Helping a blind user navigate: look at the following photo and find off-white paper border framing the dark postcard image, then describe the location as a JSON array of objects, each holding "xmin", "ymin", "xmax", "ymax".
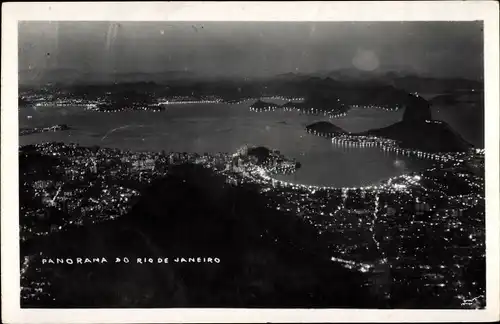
[{"xmin": 1, "ymin": 1, "xmax": 500, "ymax": 323}]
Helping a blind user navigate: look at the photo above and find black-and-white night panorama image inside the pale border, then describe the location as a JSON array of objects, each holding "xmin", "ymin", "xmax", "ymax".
[{"xmin": 2, "ymin": 4, "xmax": 498, "ymax": 322}]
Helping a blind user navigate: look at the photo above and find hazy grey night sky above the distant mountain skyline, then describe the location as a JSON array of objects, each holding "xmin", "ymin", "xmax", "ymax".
[{"xmin": 19, "ymin": 21, "xmax": 483, "ymax": 79}]
